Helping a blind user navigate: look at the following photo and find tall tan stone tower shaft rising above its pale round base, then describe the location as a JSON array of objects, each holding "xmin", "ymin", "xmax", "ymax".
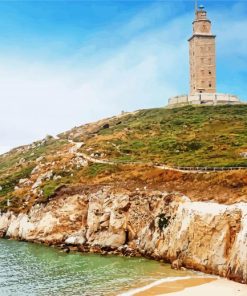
[{"xmin": 189, "ymin": 6, "xmax": 216, "ymax": 95}]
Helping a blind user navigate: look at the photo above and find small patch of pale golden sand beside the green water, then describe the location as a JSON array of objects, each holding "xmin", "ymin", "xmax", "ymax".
[{"xmin": 123, "ymin": 277, "xmax": 247, "ymax": 296}]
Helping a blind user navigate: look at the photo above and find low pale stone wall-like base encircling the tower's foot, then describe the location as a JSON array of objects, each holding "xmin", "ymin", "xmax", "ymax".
[{"xmin": 167, "ymin": 93, "xmax": 242, "ymax": 108}]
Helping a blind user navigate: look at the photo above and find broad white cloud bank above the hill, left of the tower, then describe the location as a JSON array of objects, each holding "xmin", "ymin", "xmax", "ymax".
[{"xmin": 0, "ymin": 8, "xmax": 187, "ymax": 151}]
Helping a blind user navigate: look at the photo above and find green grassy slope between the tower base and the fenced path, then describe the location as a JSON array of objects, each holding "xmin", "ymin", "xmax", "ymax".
[{"xmin": 85, "ymin": 105, "xmax": 247, "ymax": 167}]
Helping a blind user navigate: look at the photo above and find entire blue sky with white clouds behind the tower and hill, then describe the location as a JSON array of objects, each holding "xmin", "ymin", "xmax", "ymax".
[{"xmin": 0, "ymin": 0, "xmax": 247, "ymax": 152}]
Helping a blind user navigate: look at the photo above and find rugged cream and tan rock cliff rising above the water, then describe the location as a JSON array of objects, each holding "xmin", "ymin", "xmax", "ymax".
[{"xmin": 0, "ymin": 187, "xmax": 247, "ymax": 283}]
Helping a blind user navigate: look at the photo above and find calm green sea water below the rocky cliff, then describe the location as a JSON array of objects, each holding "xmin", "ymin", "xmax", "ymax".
[{"xmin": 0, "ymin": 239, "xmax": 191, "ymax": 296}]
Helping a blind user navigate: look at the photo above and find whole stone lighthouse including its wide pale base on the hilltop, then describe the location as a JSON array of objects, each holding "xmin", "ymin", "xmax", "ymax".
[{"xmin": 168, "ymin": 5, "xmax": 241, "ymax": 108}]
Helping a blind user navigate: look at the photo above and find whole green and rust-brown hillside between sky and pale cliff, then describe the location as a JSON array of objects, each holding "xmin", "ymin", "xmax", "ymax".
[{"xmin": 0, "ymin": 105, "xmax": 247, "ymax": 212}]
